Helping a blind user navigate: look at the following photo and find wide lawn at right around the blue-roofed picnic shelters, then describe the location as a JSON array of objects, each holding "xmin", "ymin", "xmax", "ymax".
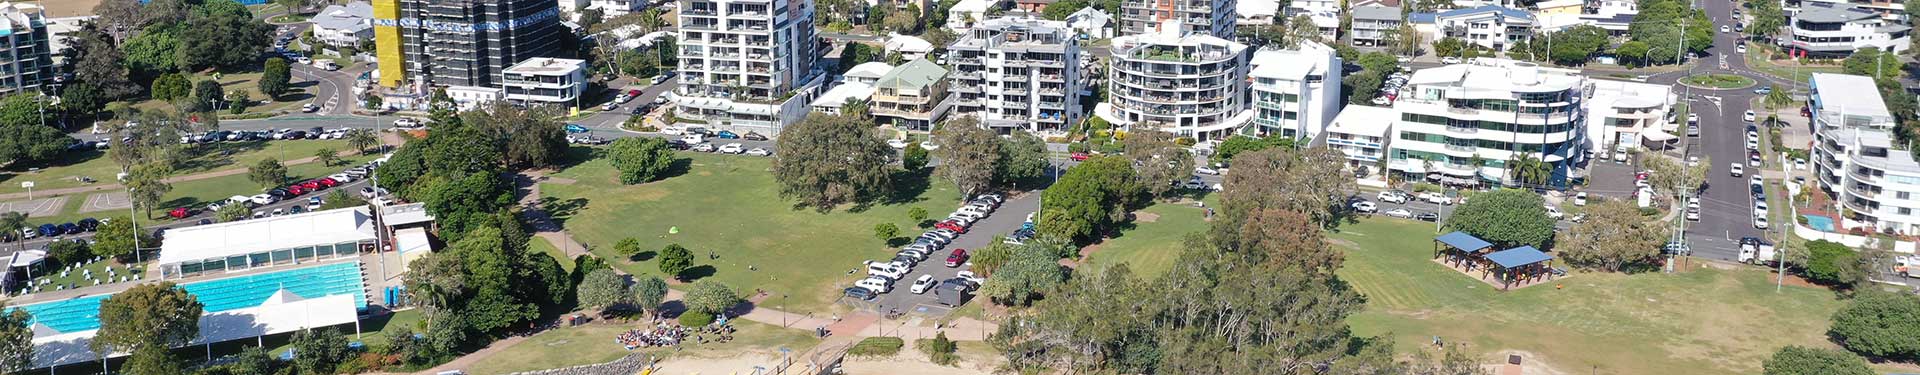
[{"xmin": 1332, "ymin": 219, "xmax": 1841, "ymax": 373}]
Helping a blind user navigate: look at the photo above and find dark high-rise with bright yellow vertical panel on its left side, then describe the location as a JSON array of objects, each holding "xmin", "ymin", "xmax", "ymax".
[{"xmin": 372, "ymin": 0, "xmax": 574, "ymax": 88}]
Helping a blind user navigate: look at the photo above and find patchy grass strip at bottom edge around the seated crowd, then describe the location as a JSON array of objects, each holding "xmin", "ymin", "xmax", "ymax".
[{"xmin": 467, "ymin": 319, "xmax": 820, "ymax": 375}]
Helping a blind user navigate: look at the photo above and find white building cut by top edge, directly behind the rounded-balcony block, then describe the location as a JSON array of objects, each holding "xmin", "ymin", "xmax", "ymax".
[{"xmin": 1119, "ymin": 0, "xmax": 1236, "ymax": 38}]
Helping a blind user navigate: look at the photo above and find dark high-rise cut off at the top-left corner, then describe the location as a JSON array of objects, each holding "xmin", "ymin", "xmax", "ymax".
[{"xmin": 0, "ymin": 2, "xmax": 54, "ymax": 94}]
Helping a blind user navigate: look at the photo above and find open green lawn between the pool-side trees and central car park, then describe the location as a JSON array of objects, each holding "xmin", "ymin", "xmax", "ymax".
[{"xmin": 540, "ymin": 152, "xmax": 960, "ymax": 313}]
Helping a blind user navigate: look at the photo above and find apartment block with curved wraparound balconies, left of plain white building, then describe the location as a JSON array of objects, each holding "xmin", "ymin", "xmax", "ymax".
[{"xmin": 1094, "ymin": 21, "xmax": 1254, "ymax": 142}]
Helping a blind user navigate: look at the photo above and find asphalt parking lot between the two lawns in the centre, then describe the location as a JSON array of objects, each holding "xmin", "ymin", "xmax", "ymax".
[{"xmin": 843, "ymin": 192, "xmax": 1041, "ymax": 315}]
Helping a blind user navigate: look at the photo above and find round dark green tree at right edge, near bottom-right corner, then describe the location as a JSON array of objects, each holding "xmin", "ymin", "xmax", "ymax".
[{"xmin": 1826, "ymin": 290, "xmax": 1920, "ymax": 360}]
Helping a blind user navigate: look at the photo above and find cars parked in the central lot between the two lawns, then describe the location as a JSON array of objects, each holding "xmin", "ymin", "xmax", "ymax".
[{"xmin": 845, "ymin": 194, "xmax": 1006, "ymax": 304}]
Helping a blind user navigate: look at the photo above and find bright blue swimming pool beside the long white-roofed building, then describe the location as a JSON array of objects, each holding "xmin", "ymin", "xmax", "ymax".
[{"xmin": 8, "ymin": 262, "xmax": 367, "ymax": 333}]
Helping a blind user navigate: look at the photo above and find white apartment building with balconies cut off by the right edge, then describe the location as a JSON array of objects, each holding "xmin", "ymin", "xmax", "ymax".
[{"xmin": 1812, "ymin": 127, "xmax": 1920, "ymax": 235}]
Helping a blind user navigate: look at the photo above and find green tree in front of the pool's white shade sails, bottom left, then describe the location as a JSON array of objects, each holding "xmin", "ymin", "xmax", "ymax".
[{"xmin": 88, "ymin": 281, "xmax": 205, "ymax": 363}]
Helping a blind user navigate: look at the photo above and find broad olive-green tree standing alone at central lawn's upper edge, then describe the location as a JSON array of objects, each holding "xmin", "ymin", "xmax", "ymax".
[{"xmin": 774, "ymin": 113, "xmax": 893, "ymax": 212}]
